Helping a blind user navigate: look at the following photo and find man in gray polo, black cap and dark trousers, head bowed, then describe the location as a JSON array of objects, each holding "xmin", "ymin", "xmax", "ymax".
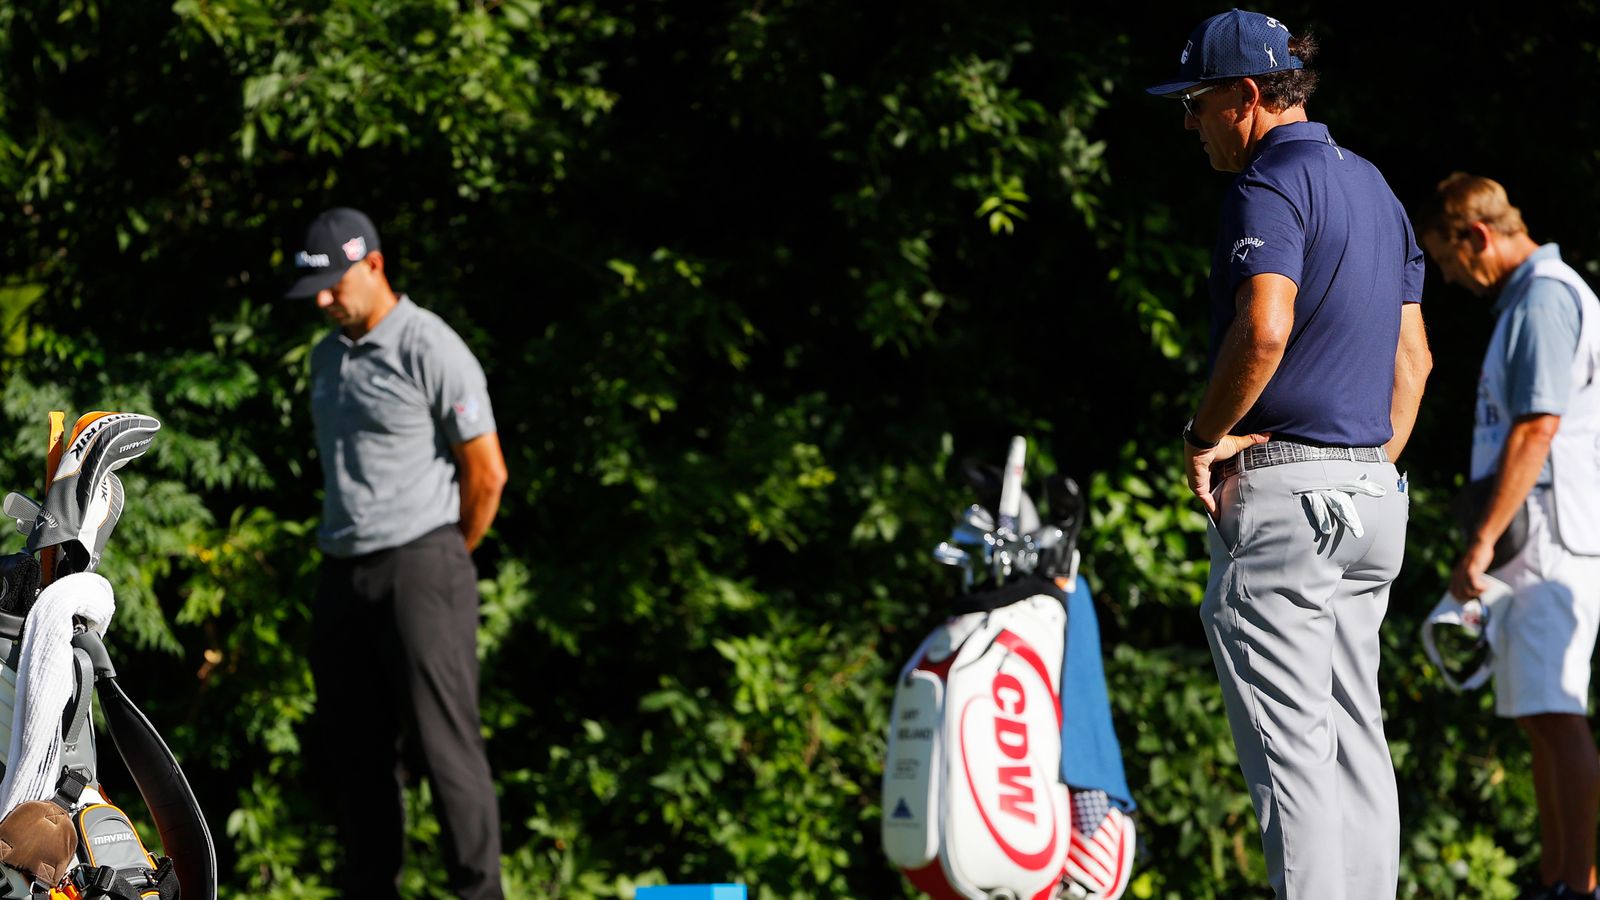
[{"xmin": 286, "ymin": 208, "xmax": 506, "ymax": 900}]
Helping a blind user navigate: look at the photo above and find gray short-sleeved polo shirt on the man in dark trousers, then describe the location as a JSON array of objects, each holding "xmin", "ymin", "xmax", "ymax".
[{"xmin": 310, "ymin": 295, "xmax": 494, "ymax": 557}]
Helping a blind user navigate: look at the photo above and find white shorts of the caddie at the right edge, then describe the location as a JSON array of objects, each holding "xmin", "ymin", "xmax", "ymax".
[{"xmin": 1490, "ymin": 488, "xmax": 1600, "ymax": 719}]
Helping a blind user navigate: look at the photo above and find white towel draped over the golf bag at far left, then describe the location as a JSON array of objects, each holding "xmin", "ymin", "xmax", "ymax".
[{"xmin": 0, "ymin": 572, "xmax": 117, "ymax": 817}]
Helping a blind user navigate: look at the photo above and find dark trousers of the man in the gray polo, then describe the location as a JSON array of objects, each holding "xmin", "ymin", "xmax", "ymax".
[{"xmin": 310, "ymin": 525, "xmax": 501, "ymax": 900}]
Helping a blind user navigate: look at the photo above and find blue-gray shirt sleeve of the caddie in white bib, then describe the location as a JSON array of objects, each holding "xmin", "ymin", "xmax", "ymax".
[{"xmin": 1506, "ymin": 279, "xmax": 1582, "ymax": 418}]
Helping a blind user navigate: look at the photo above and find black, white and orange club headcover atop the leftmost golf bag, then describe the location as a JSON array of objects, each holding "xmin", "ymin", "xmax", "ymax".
[{"xmin": 27, "ymin": 413, "xmax": 162, "ymax": 577}]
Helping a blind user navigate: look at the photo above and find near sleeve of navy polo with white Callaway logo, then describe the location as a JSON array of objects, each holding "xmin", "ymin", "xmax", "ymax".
[{"xmin": 1221, "ymin": 178, "xmax": 1306, "ymax": 295}]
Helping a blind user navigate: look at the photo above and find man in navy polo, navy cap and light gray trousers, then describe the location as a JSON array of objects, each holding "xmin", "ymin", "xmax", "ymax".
[{"xmin": 1149, "ymin": 10, "xmax": 1432, "ymax": 900}]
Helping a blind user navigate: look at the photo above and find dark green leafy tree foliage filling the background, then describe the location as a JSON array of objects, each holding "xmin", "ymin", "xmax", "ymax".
[{"xmin": 0, "ymin": 0, "xmax": 1600, "ymax": 898}]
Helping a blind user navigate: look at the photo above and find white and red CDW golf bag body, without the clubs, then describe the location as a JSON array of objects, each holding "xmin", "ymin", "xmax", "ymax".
[{"xmin": 883, "ymin": 593, "xmax": 1072, "ymax": 900}]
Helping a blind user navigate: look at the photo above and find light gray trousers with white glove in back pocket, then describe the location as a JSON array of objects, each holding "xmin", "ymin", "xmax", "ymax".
[{"xmin": 1200, "ymin": 460, "xmax": 1410, "ymax": 900}]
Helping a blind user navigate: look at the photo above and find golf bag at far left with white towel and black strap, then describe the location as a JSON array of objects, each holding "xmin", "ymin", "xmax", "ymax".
[{"xmin": 0, "ymin": 413, "xmax": 216, "ymax": 900}]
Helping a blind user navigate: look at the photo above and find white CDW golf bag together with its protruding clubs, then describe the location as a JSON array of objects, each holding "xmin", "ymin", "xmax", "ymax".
[{"xmin": 883, "ymin": 437, "xmax": 1082, "ymax": 900}]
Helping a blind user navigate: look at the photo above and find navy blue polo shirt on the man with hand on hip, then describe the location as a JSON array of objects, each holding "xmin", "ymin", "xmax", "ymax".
[{"xmin": 1210, "ymin": 122, "xmax": 1422, "ymax": 447}]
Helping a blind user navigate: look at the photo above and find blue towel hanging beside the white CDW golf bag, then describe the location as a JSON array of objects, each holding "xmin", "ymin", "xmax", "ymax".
[{"xmin": 1061, "ymin": 575, "xmax": 1134, "ymax": 812}]
